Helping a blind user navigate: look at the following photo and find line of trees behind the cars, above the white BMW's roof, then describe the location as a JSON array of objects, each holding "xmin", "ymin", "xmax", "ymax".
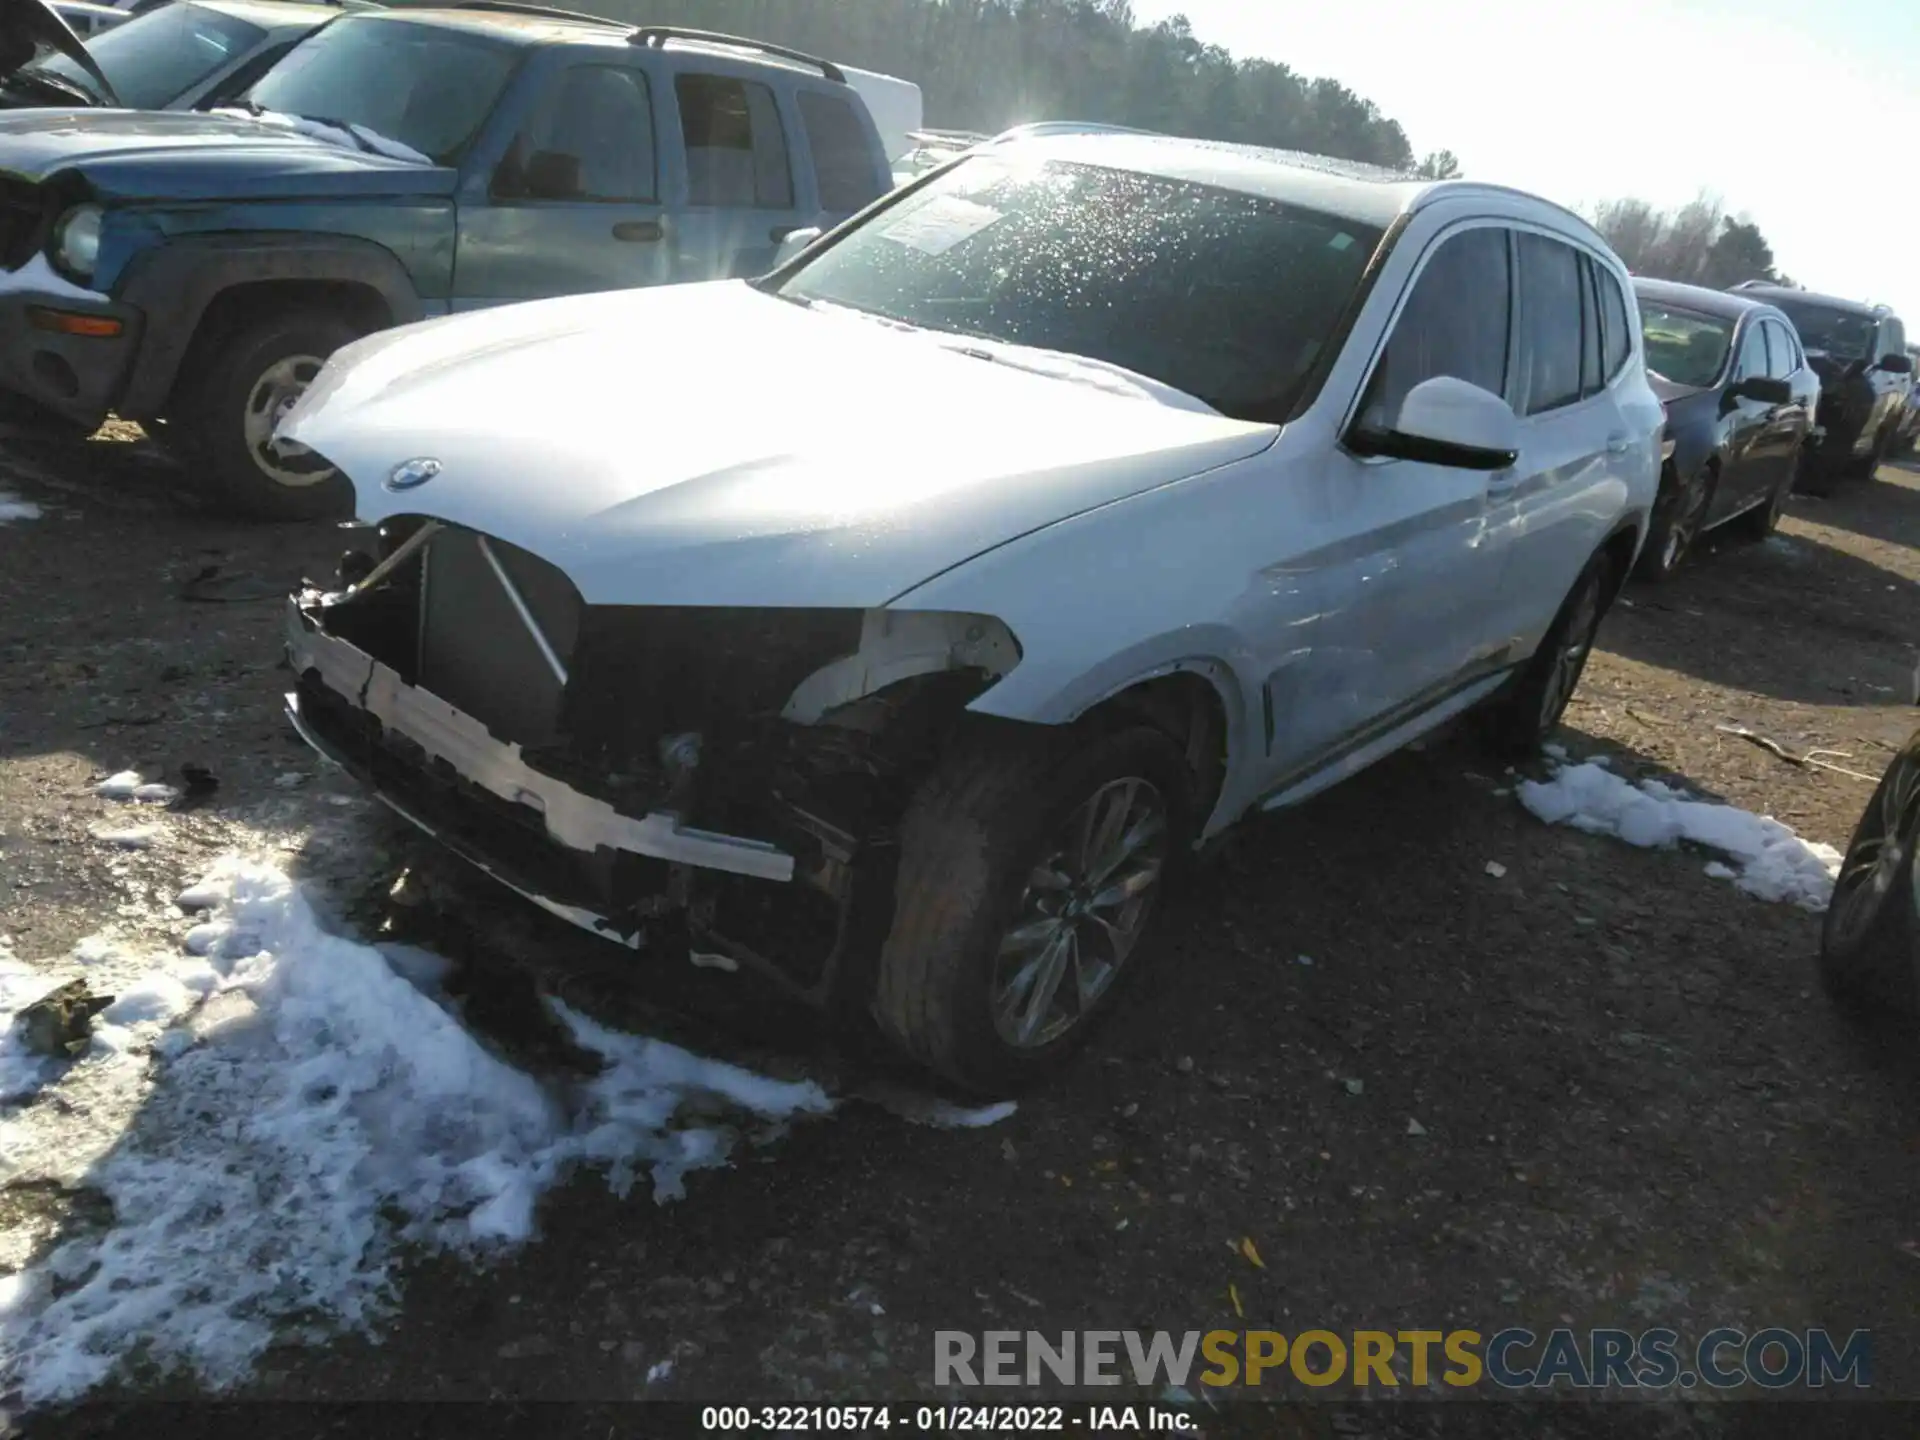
[{"xmin": 583, "ymin": 0, "xmax": 1457, "ymax": 173}]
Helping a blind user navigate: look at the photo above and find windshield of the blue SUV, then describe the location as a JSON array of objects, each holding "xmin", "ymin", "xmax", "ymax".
[{"xmin": 248, "ymin": 17, "xmax": 518, "ymax": 165}]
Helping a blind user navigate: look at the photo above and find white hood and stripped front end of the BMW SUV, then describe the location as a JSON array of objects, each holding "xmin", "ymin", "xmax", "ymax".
[{"xmin": 266, "ymin": 282, "xmax": 1271, "ymax": 1002}]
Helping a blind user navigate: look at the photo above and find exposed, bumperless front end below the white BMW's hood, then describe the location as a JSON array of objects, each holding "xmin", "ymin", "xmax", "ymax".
[{"xmin": 288, "ymin": 518, "xmax": 1020, "ymax": 1002}]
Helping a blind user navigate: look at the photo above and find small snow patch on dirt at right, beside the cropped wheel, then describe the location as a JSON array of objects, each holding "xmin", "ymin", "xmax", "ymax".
[{"xmin": 1519, "ymin": 747, "xmax": 1841, "ymax": 910}]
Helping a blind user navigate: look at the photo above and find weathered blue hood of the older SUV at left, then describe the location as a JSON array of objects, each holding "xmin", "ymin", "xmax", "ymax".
[{"xmin": 0, "ymin": 109, "xmax": 455, "ymax": 200}]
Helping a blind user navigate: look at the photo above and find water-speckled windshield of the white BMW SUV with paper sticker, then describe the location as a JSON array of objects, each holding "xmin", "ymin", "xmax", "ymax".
[{"xmin": 778, "ymin": 156, "xmax": 1380, "ymax": 420}]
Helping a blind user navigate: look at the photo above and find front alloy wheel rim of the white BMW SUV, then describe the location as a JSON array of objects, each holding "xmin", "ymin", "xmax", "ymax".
[{"xmin": 989, "ymin": 776, "xmax": 1169, "ymax": 1050}]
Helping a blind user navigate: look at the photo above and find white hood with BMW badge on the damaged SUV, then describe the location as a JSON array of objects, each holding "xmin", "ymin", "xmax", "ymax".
[{"xmin": 280, "ymin": 280, "xmax": 1279, "ymax": 607}]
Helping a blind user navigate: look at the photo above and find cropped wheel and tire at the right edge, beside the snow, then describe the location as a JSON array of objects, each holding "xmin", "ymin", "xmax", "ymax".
[{"xmin": 1820, "ymin": 735, "xmax": 1920, "ymax": 1021}]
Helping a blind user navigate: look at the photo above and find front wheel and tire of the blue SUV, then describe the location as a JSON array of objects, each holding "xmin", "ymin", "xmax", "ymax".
[{"xmin": 179, "ymin": 311, "xmax": 361, "ymax": 520}]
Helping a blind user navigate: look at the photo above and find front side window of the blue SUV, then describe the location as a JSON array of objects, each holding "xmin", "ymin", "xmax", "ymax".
[{"xmin": 493, "ymin": 65, "xmax": 657, "ymax": 202}]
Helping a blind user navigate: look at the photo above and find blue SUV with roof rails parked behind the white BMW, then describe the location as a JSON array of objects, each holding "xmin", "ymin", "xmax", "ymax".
[{"xmin": 0, "ymin": 0, "xmax": 891, "ymax": 518}]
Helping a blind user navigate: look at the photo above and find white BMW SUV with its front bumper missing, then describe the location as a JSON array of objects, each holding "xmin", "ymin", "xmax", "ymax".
[{"xmin": 280, "ymin": 134, "xmax": 1663, "ymax": 1091}]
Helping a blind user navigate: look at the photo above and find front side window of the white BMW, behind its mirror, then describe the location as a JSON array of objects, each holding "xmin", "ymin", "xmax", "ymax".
[{"xmin": 1359, "ymin": 227, "xmax": 1513, "ymax": 430}]
